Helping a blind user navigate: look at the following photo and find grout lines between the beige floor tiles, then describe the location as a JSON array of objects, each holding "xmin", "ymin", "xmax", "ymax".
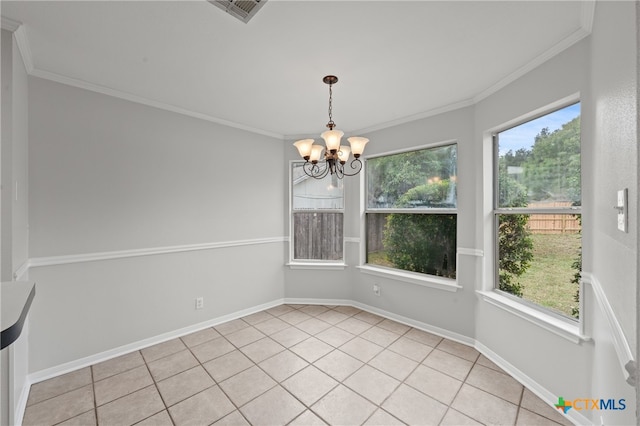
[{"xmin": 22, "ymin": 304, "xmax": 568, "ymax": 425}]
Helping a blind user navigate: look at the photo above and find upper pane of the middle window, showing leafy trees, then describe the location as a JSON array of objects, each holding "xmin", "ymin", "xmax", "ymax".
[{"xmin": 367, "ymin": 145, "xmax": 457, "ymax": 208}]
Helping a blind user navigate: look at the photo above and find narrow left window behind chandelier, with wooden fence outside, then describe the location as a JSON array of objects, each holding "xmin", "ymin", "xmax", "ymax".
[{"xmin": 291, "ymin": 162, "xmax": 344, "ymax": 261}]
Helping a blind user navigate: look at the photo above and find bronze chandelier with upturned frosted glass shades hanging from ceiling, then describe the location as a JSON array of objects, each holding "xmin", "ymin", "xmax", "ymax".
[{"xmin": 293, "ymin": 75, "xmax": 369, "ymax": 179}]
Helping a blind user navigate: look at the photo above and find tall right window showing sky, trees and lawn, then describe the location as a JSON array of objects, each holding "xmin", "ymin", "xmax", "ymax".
[{"xmin": 494, "ymin": 103, "xmax": 582, "ymax": 319}]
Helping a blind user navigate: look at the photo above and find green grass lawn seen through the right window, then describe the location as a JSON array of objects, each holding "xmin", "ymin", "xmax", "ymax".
[{"xmin": 518, "ymin": 234, "xmax": 581, "ymax": 316}]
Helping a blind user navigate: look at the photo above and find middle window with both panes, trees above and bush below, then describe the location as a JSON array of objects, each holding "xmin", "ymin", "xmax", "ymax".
[{"xmin": 365, "ymin": 144, "xmax": 457, "ymax": 278}]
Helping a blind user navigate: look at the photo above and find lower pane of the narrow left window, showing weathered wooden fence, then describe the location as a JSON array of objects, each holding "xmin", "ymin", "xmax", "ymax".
[{"xmin": 293, "ymin": 212, "xmax": 343, "ymax": 260}]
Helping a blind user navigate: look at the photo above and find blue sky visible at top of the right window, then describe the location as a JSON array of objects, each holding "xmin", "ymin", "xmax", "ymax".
[{"xmin": 499, "ymin": 103, "xmax": 580, "ymax": 156}]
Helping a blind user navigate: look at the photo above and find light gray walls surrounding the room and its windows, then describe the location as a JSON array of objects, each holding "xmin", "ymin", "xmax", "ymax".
[{"xmin": 3, "ymin": 2, "xmax": 638, "ymax": 424}]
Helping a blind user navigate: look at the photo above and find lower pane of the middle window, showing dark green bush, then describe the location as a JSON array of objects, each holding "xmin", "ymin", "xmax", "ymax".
[{"xmin": 367, "ymin": 213, "xmax": 456, "ymax": 278}]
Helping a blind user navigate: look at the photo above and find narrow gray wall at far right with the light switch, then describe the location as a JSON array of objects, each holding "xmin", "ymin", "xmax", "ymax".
[{"xmin": 585, "ymin": 2, "xmax": 640, "ymax": 424}]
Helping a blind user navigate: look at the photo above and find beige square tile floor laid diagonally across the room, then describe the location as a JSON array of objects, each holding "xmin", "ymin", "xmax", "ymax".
[{"xmin": 23, "ymin": 305, "xmax": 571, "ymax": 426}]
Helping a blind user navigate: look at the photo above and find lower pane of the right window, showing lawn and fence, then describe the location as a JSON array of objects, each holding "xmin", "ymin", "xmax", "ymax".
[{"xmin": 498, "ymin": 214, "xmax": 582, "ymax": 317}]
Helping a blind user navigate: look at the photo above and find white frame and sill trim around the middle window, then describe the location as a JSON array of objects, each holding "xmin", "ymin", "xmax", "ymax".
[{"xmin": 356, "ymin": 139, "xmax": 463, "ymax": 282}]
